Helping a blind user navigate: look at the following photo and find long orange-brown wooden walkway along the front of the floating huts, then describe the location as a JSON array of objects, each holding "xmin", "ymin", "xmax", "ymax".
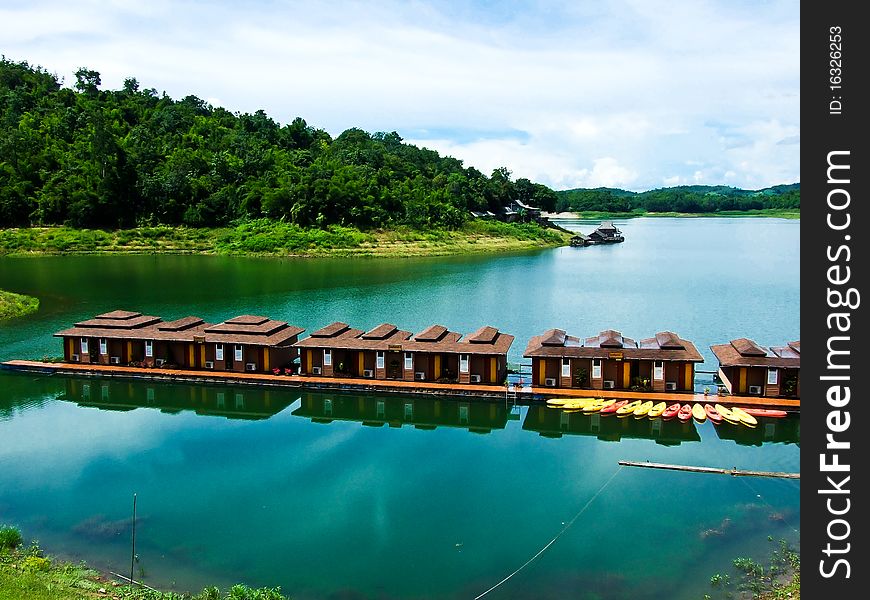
[{"xmin": 0, "ymin": 360, "xmax": 800, "ymax": 411}]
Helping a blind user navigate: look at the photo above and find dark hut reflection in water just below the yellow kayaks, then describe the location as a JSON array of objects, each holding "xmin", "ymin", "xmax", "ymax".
[{"xmin": 523, "ymin": 406, "xmax": 701, "ymax": 446}]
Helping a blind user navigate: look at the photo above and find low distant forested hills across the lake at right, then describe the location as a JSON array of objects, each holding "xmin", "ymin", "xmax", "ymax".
[{"xmin": 556, "ymin": 183, "xmax": 801, "ymax": 213}]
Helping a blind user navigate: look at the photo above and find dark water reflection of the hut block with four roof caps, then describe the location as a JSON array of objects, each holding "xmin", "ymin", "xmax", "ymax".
[{"xmin": 293, "ymin": 394, "xmax": 509, "ymax": 433}]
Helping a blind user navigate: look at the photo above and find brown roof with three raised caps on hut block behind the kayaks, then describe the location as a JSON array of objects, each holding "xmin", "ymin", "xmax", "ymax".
[{"xmin": 523, "ymin": 329, "xmax": 704, "ymax": 362}]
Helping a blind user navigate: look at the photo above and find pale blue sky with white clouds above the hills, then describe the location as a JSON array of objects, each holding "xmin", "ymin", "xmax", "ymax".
[{"xmin": 0, "ymin": 0, "xmax": 800, "ymax": 190}]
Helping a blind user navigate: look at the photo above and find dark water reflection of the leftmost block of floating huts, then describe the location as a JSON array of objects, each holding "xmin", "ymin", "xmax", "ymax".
[{"xmin": 62, "ymin": 378, "xmax": 296, "ymax": 420}]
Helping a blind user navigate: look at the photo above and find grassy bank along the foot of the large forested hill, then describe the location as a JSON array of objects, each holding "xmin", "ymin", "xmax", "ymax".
[{"xmin": 0, "ymin": 219, "xmax": 570, "ymax": 257}]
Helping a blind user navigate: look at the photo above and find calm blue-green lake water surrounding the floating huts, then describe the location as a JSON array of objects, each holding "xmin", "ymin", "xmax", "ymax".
[{"xmin": 0, "ymin": 219, "xmax": 800, "ymax": 598}]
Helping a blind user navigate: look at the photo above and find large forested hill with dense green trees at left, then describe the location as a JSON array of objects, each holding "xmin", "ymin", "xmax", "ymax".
[{"xmin": 0, "ymin": 57, "xmax": 556, "ymax": 229}]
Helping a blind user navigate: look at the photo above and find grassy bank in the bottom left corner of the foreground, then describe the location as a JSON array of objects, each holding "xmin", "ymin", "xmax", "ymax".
[{"xmin": 0, "ymin": 526, "xmax": 286, "ymax": 600}]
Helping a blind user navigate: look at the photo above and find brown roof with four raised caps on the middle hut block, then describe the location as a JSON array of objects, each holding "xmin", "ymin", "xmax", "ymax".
[{"xmin": 295, "ymin": 323, "xmax": 514, "ymax": 354}]
